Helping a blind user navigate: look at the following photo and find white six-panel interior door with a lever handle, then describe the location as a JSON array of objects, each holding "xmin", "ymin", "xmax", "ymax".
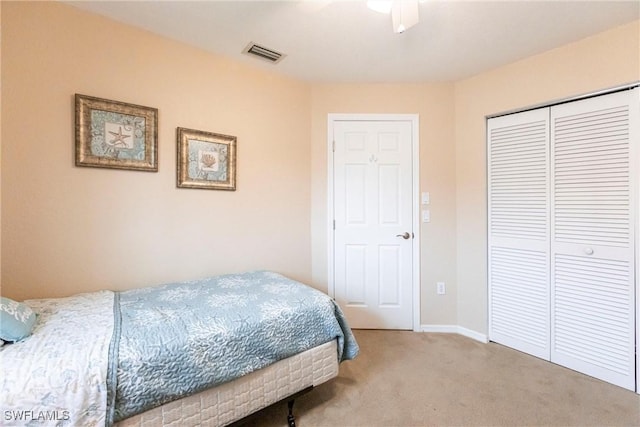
[{"xmin": 333, "ymin": 120, "xmax": 414, "ymax": 329}]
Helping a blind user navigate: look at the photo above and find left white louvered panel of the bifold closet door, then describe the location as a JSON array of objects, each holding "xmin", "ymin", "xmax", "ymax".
[{"xmin": 487, "ymin": 108, "xmax": 550, "ymax": 360}]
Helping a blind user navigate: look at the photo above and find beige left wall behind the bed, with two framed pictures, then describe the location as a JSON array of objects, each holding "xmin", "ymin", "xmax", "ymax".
[{"xmin": 2, "ymin": 2, "xmax": 311, "ymax": 299}]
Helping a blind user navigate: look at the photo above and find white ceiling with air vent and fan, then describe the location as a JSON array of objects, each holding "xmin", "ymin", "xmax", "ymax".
[{"xmin": 63, "ymin": 0, "xmax": 640, "ymax": 83}]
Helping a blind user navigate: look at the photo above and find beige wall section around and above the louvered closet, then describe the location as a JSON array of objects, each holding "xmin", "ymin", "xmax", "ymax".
[{"xmin": 455, "ymin": 21, "xmax": 640, "ymax": 333}]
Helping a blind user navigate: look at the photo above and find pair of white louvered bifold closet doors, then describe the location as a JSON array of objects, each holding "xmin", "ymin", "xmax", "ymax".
[{"xmin": 487, "ymin": 88, "xmax": 640, "ymax": 390}]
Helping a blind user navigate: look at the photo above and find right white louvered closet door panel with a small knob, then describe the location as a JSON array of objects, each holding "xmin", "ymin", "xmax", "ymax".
[{"xmin": 551, "ymin": 90, "xmax": 638, "ymax": 390}]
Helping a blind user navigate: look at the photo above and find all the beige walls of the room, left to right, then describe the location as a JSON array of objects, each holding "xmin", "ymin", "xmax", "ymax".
[{"xmin": 0, "ymin": 2, "xmax": 640, "ymax": 333}]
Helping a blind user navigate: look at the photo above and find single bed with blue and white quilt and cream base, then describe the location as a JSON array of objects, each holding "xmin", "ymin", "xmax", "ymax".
[{"xmin": 0, "ymin": 271, "xmax": 358, "ymax": 427}]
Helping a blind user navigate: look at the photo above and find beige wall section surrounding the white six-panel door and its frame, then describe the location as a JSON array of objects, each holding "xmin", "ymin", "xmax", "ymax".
[{"xmin": 311, "ymin": 83, "xmax": 457, "ymax": 324}]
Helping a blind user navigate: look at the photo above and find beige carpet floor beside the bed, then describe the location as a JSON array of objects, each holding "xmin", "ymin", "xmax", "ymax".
[{"xmin": 247, "ymin": 330, "xmax": 640, "ymax": 427}]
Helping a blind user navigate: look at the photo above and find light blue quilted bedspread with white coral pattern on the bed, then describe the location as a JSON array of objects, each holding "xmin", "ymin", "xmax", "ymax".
[{"xmin": 107, "ymin": 272, "xmax": 358, "ymax": 422}]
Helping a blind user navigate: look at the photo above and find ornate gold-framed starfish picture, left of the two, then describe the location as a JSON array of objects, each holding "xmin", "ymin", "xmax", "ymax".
[{"xmin": 75, "ymin": 94, "xmax": 158, "ymax": 172}]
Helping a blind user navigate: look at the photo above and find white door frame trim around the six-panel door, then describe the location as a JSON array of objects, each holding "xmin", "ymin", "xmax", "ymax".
[{"xmin": 327, "ymin": 113, "xmax": 420, "ymax": 332}]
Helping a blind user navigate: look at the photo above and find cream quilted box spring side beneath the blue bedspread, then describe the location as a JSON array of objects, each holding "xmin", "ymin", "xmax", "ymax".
[{"xmin": 115, "ymin": 340, "xmax": 338, "ymax": 427}]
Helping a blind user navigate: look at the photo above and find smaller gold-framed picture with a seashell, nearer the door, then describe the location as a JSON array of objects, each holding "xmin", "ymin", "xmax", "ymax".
[{"xmin": 176, "ymin": 127, "xmax": 237, "ymax": 191}]
